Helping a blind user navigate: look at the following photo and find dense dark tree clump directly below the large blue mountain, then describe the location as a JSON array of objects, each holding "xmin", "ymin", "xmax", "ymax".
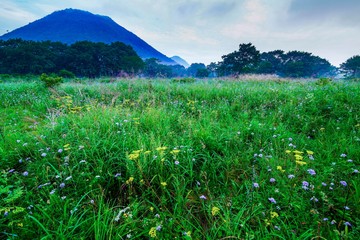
[{"xmin": 0, "ymin": 39, "xmax": 144, "ymax": 77}]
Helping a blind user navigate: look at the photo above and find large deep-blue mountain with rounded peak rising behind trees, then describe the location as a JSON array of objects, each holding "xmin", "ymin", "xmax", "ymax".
[{"xmin": 0, "ymin": 9, "xmax": 176, "ymax": 65}]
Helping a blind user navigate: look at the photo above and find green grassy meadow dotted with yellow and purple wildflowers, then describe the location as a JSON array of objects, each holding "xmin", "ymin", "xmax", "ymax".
[{"xmin": 0, "ymin": 79, "xmax": 360, "ymax": 239}]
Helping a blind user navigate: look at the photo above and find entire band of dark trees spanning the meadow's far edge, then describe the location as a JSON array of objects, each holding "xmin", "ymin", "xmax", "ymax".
[{"xmin": 0, "ymin": 39, "xmax": 360, "ymax": 78}]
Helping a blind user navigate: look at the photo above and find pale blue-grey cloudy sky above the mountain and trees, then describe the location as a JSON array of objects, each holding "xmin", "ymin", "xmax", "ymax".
[{"xmin": 0, "ymin": 0, "xmax": 360, "ymax": 66}]
